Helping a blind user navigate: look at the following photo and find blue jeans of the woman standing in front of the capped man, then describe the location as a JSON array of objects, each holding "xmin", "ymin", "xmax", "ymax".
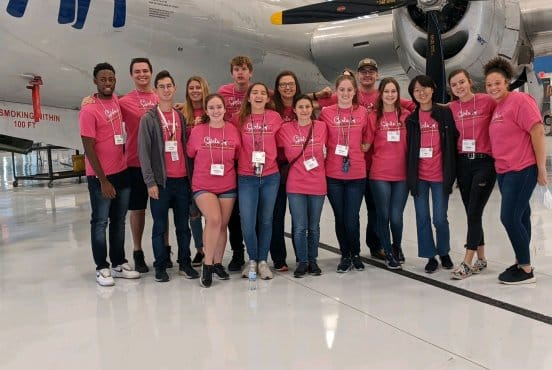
[{"xmin": 326, "ymin": 177, "xmax": 366, "ymax": 257}]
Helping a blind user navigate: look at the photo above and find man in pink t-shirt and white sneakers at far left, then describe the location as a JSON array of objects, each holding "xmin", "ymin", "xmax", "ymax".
[{"xmin": 79, "ymin": 63, "xmax": 140, "ymax": 286}]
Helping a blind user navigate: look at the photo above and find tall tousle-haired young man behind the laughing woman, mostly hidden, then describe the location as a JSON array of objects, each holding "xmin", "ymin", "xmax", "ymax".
[{"xmin": 217, "ymin": 55, "xmax": 253, "ymax": 271}]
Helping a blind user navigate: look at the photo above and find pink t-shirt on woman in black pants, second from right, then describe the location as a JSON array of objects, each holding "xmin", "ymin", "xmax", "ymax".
[{"xmin": 449, "ymin": 94, "xmax": 496, "ymax": 155}]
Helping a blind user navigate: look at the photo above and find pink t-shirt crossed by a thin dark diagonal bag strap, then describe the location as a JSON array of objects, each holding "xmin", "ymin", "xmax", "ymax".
[{"xmin": 277, "ymin": 121, "xmax": 328, "ymax": 195}]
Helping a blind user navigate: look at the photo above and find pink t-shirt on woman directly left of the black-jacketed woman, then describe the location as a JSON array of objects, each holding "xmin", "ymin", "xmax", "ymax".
[{"xmin": 368, "ymin": 109, "xmax": 410, "ymax": 181}]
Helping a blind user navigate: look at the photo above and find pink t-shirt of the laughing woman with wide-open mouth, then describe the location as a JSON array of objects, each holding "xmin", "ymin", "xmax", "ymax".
[{"xmin": 237, "ymin": 109, "xmax": 282, "ymax": 176}]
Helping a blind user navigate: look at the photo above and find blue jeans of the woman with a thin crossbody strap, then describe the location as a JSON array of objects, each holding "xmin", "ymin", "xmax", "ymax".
[{"xmin": 288, "ymin": 193, "xmax": 325, "ymax": 262}]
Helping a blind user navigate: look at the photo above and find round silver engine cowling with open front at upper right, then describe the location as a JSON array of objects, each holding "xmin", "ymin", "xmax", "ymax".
[{"xmin": 393, "ymin": 0, "xmax": 533, "ymax": 84}]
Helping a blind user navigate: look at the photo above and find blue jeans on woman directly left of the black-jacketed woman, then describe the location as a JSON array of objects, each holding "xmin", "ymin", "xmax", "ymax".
[{"xmin": 370, "ymin": 180, "xmax": 408, "ymax": 253}]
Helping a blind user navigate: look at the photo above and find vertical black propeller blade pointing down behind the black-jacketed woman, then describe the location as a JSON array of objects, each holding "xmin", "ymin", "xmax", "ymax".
[{"xmin": 426, "ymin": 10, "xmax": 448, "ymax": 103}]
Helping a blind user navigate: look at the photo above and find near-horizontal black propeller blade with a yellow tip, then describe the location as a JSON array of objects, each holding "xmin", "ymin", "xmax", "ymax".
[{"xmin": 270, "ymin": 0, "xmax": 416, "ymax": 25}]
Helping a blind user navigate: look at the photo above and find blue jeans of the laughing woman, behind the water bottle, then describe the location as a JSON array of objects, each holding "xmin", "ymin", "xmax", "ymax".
[{"xmin": 238, "ymin": 173, "xmax": 280, "ymax": 261}]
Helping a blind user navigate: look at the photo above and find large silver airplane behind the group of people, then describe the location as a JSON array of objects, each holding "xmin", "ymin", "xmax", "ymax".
[{"xmin": 0, "ymin": 0, "xmax": 552, "ymax": 149}]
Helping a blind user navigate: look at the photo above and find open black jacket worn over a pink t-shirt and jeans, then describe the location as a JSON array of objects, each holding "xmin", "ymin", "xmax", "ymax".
[{"xmin": 406, "ymin": 104, "xmax": 459, "ymax": 196}]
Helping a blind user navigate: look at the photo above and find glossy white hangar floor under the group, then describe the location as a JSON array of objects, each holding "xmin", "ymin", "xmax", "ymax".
[{"xmin": 0, "ymin": 145, "xmax": 552, "ymax": 370}]
